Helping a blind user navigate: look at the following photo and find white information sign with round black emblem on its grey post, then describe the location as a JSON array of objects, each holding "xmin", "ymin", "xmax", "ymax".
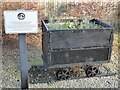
[{"xmin": 4, "ymin": 10, "xmax": 38, "ymax": 89}]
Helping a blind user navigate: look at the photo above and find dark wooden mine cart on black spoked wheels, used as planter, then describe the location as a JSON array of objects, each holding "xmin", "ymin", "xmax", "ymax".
[{"xmin": 28, "ymin": 19, "xmax": 114, "ymax": 83}]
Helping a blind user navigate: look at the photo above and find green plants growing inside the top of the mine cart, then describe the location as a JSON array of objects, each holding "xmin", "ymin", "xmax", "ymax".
[{"xmin": 47, "ymin": 19, "xmax": 104, "ymax": 30}]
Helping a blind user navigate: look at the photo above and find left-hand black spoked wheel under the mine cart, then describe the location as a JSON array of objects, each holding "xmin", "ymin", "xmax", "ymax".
[{"xmin": 56, "ymin": 69, "xmax": 70, "ymax": 80}]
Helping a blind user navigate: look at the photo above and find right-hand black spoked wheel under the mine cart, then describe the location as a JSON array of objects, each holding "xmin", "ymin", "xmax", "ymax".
[{"xmin": 85, "ymin": 66, "xmax": 99, "ymax": 77}]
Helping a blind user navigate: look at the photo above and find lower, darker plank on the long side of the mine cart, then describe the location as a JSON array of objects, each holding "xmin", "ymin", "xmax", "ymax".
[{"xmin": 51, "ymin": 48, "xmax": 109, "ymax": 65}]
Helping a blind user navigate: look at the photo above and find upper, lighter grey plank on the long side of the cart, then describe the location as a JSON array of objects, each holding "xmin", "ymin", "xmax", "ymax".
[{"xmin": 50, "ymin": 30, "xmax": 112, "ymax": 49}]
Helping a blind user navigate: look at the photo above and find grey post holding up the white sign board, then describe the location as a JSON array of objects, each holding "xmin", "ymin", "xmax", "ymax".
[{"xmin": 19, "ymin": 34, "xmax": 28, "ymax": 89}]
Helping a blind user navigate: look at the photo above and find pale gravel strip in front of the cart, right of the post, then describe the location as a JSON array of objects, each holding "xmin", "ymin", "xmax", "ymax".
[{"xmin": 30, "ymin": 76, "xmax": 118, "ymax": 88}]
